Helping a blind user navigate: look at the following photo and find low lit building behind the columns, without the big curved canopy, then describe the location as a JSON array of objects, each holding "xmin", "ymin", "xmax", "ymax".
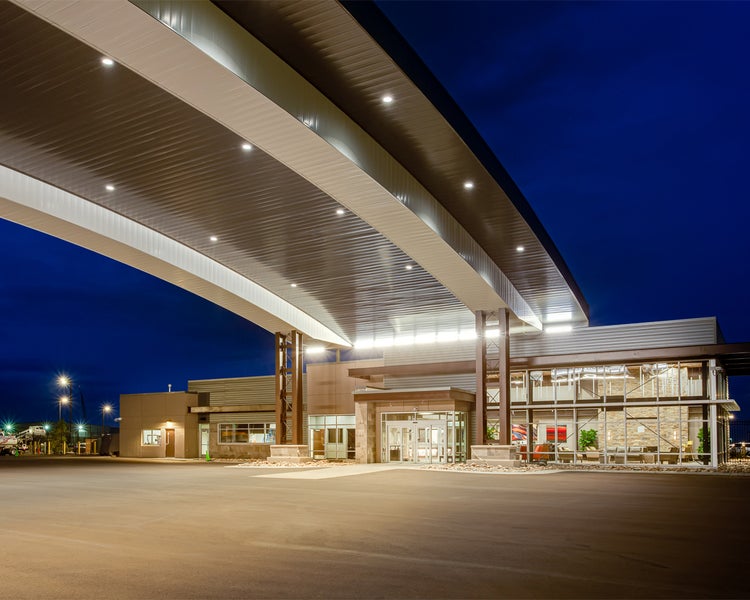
[{"xmin": 120, "ymin": 318, "xmax": 747, "ymax": 466}]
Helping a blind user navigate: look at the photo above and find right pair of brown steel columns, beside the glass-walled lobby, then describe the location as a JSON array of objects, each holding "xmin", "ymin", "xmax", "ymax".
[{"xmin": 474, "ymin": 309, "xmax": 511, "ymax": 445}]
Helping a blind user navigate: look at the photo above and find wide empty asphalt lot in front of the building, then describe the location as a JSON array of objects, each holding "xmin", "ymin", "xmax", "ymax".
[{"xmin": 0, "ymin": 457, "xmax": 750, "ymax": 600}]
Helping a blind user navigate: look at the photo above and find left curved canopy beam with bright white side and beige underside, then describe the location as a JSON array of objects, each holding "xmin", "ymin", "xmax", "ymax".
[{"xmin": 0, "ymin": 166, "xmax": 350, "ymax": 346}]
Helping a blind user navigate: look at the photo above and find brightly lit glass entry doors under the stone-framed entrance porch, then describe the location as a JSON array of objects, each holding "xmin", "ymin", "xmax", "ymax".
[{"xmin": 381, "ymin": 411, "xmax": 467, "ymax": 463}]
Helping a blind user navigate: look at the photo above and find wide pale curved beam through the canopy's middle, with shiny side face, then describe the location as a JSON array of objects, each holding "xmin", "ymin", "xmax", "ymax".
[{"xmin": 116, "ymin": 0, "xmax": 541, "ymax": 326}]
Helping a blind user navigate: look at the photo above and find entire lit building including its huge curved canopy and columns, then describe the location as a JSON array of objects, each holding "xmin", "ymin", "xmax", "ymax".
[{"xmin": 0, "ymin": 0, "xmax": 750, "ymax": 466}]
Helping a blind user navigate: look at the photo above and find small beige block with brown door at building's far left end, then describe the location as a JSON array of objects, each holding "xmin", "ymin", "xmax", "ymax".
[{"xmin": 120, "ymin": 392, "xmax": 200, "ymax": 458}]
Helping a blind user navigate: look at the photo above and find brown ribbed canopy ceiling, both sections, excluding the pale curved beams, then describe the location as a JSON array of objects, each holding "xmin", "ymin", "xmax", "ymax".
[{"xmin": 0, "ymin": 2, "xmax": 586, "ymax": 341}]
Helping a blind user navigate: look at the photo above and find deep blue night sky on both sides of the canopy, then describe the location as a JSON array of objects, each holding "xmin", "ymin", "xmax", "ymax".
[{"xmin": 0, "ymin": 1, "xmax": 750, "ymax": 421}]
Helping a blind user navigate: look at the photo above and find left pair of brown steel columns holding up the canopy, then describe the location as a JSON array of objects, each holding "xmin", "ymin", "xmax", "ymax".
[{"xmin": 275, "ymin": 331, "xmax": 304, "ymax": 444}]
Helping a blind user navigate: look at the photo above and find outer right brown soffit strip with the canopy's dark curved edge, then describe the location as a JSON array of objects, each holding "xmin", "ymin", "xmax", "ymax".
[{"xmin": 214, "ymin": 0, "xmax": 588, "ymax": 321}]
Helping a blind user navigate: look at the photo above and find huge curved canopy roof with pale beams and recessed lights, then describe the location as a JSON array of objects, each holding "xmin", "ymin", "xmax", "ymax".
[{"xmin": 0, "ymin": 0, "xmax": 588, "ymax": 345}]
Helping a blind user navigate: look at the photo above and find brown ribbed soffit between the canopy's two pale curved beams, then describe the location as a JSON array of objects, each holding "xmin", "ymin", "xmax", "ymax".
[{"xmin": 0, "ymin": 3, "xmax": 471, "ymax": 341}]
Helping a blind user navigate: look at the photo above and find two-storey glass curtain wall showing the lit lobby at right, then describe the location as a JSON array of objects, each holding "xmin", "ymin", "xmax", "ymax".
[{"xmin": 511, "ymin": 361, "xmax": 728, "ymax": 465}]
